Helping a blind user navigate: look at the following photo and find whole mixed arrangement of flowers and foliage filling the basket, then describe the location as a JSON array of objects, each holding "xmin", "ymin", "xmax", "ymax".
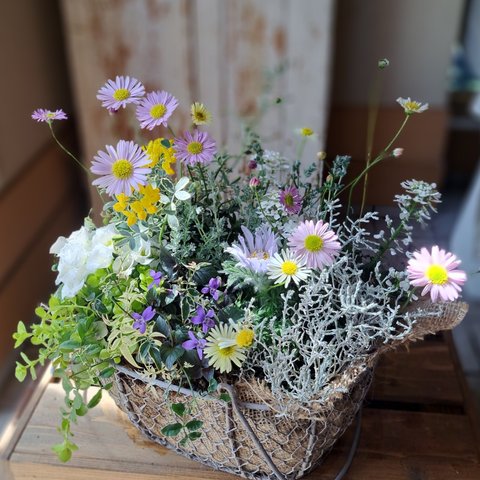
[{"xmin": 14, "ymin": 73, "xmax": 466, "ymax": 470}]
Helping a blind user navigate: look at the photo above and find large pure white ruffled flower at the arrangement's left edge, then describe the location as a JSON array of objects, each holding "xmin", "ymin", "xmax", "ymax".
[{"xmin": 50, "ymin": 225, "xmax": 117, "ymax": 298}]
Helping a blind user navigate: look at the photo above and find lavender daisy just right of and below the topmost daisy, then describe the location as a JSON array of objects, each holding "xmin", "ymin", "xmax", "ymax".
[{"xmin": 136, "ymin": 90, "xmax": 178, "ymax": 130}]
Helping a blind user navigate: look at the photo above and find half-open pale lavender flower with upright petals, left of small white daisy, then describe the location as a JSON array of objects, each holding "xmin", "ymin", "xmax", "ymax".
[{"xmin": 225, "ymin": 225, "xmax": 278, "ymax": 273}]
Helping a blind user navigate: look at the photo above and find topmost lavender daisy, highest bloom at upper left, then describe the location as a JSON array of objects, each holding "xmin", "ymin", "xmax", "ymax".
[{"xmin": 97, "ymin": 76, "xmax": 145, "ymax": 113}]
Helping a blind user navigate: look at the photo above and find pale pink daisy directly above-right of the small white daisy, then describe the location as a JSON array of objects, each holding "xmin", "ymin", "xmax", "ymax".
[{"xmin": 288, "ymin": 220, "xmax": 341, "ymax": 269}]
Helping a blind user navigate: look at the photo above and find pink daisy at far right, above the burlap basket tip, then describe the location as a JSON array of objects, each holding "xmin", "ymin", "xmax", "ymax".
[{"xmin": 407, "ymin": 245, "xmax": 467, "ymax": 302}]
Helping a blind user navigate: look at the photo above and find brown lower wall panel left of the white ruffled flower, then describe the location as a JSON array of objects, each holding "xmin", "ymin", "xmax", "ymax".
[{"xmin": 0, "ymin": 136, "xmax": 84, "ymax": 384}]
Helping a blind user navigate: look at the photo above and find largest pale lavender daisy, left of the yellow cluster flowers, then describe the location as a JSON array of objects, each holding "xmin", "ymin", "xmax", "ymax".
[{"xmin": 90, "ymin": 140, "xmax": 152, "ymax": 196}]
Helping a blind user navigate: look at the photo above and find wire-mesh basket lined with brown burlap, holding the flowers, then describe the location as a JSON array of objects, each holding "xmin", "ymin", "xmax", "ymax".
[{"xmin": 107, "ymin": 303, "xmax": 468, "ymax": 480}]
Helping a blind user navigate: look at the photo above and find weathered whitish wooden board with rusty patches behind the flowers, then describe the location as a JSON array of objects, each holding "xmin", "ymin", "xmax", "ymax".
[{"xmin": 62, "ymin": 0, "xmax": 334, "ymax": 214}]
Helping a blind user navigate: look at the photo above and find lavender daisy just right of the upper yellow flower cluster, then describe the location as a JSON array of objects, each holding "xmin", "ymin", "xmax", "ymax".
[{"xmin": 173, "ymin": 130, "xmax": 217, "ymax": 165}]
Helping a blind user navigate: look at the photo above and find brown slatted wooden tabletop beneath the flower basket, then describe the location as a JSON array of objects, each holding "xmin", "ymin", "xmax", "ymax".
[{"xmin": 0, "ymin": 335, "xmax": 480, "ymax": 480}]
